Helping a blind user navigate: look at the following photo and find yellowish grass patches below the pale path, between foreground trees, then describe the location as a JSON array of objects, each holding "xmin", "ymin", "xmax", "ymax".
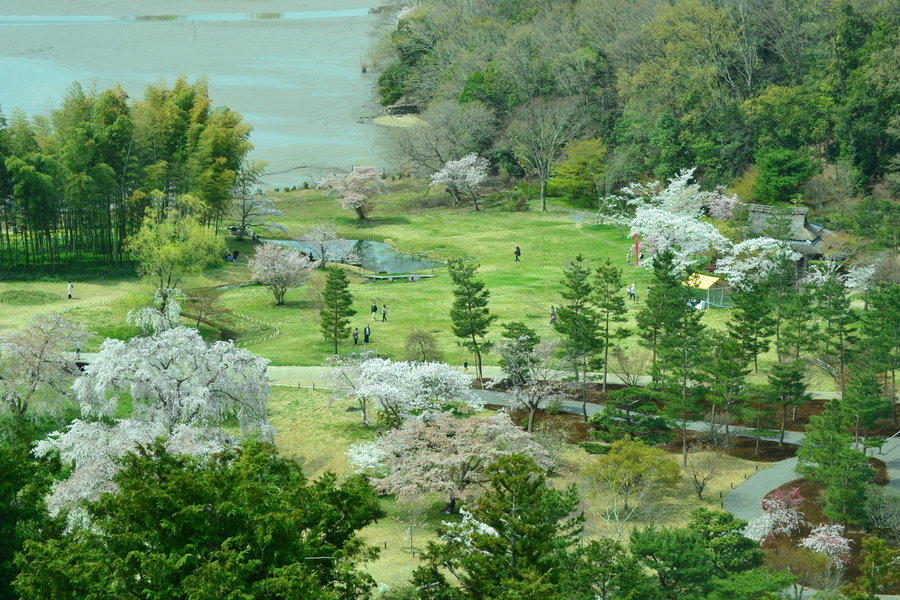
[{"xmin": 269, "ymin": 387, "xmax": 768, "ymax": 587}]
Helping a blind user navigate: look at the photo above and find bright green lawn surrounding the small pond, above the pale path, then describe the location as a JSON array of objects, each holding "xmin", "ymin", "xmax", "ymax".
[{"xmin": 0, "ymin": 180, "xmax": 833, "ymax": 389}]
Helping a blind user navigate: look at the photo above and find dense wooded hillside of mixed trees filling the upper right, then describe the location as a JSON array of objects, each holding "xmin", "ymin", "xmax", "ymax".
[{"xmin": 378, "ymin": 0, "xmax": 900, "ymax": 241}]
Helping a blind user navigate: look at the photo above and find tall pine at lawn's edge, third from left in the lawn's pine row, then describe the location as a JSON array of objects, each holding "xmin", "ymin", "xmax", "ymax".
[{"xmin": 553, "ymin": 254, "xmax": 600, "ymax": 420}]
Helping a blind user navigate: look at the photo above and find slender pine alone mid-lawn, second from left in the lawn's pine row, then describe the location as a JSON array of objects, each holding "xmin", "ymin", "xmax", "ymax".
[{"xmin": 447, "ymin": 260, "xmax": 497, "ymax": 381}]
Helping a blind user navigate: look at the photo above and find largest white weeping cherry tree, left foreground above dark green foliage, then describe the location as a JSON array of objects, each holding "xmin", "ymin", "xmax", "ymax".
[{"xmin": 35, "ymin": 327, "xmax": 274, "ymax": 524}]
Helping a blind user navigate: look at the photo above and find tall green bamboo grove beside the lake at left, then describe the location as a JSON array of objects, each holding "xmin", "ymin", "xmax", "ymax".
[{"xmin": 0, "ymin": 77, "xmax": 251, "ymax": 272}]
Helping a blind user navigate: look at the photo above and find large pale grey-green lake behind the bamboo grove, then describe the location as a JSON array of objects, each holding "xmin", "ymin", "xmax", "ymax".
[{"xmin": 0, "ymin": 0, "xmax": 393, "ymax": 187}]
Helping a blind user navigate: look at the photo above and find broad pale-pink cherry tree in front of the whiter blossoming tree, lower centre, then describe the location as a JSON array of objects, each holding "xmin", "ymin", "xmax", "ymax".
[{"xmin": 347, "ymin": 412, "xmax": 552, "ymax": 512}]
